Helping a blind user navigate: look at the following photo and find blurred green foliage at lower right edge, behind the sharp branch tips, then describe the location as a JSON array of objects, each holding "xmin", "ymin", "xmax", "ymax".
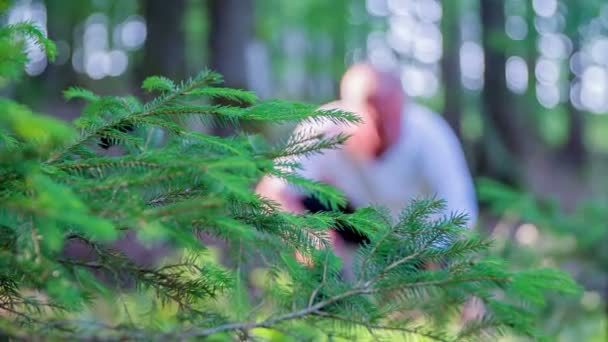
[{"xmin": 478, "ymin": 179, "xmax": 608, "ymax": 341}]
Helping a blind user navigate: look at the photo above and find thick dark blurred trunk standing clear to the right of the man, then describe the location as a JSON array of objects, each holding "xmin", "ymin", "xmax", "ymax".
[{"xmin": 478, "ymin": 0, "xmax": 527, "ymax": 183}]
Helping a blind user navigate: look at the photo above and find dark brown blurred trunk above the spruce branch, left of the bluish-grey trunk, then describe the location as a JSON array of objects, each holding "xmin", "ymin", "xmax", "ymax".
[{"xmin": 137, "ymin": 0, "xmax": 186, "ymax": 81}]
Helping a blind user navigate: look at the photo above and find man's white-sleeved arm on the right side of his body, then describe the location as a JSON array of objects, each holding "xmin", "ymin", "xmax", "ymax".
[{"xmin": 419, "ymin": 119, "xmax": 478, "ymax": 227}]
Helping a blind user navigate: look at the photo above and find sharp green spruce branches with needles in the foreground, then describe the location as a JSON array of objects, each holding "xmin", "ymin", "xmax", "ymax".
[{"xmin": 0, "ymin": 20, "xmax": 577, "ymax": 341}]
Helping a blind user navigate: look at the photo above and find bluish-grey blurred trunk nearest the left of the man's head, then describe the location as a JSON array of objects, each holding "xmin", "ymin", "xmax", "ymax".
[{"xmin": 207, "ymin": 0, "xmax": 254, "ymax": 89}]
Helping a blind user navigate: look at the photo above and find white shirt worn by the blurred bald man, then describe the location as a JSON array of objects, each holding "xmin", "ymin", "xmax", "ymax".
[{"xmin": 288, "ymin": 102, "xmax": 477, "ymax": 227}]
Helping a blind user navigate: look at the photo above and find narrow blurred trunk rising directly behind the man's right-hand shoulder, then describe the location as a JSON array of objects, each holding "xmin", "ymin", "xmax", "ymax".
[{"xmin": 441, "ymin": 0, "xmax": 462, "ymax": 138}]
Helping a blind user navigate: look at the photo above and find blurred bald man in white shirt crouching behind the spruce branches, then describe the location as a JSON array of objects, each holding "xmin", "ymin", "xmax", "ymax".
[{"xmin": 257, "ymin": 64, "xmax": 478, "ymax": 279}]
